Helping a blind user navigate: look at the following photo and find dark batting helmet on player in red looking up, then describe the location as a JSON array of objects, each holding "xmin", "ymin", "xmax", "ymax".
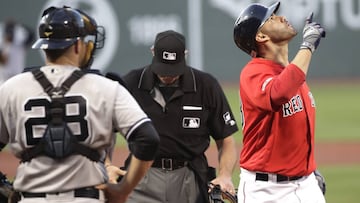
[{"xmin": 234, "ymin": 2, "xmax": 280, "ymax": 55}]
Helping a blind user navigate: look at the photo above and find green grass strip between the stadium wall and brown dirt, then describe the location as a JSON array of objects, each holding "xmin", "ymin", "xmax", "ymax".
[{"xmin": 223, "ymin": 81, "xmax": 360, "ymax": 141}]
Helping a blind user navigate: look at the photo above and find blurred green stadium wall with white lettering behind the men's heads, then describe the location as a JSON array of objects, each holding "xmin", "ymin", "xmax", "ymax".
[{"xmin": 0, "ymin": 0, "xmax": 360, "ymax": 82}]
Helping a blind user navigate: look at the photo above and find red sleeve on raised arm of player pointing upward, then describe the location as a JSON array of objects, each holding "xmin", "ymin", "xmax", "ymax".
[{"xmin": 240, "ymin": 61, "xmax": 305, "ymax": 111}]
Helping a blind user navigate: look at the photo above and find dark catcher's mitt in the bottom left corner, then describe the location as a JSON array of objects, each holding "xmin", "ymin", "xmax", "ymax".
[{"xmin": 0, "ymin": 172, "xmax": 20, "ymax": 203}]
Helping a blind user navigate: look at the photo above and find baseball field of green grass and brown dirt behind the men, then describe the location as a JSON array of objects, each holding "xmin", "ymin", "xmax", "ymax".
[{"xmin": 0, "ymin": 80, "xmax": 360, "ymax": 203}]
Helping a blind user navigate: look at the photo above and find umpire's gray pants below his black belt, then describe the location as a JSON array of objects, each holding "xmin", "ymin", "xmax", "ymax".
[{"xmin": 126, "ymin": 167, "xmax": 201, "ymax": 203}]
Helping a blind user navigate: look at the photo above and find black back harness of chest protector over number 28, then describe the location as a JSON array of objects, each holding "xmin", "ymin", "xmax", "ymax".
[{"xmin": 22, "ymin": 69, "xmax": 100, "ymax": 162}]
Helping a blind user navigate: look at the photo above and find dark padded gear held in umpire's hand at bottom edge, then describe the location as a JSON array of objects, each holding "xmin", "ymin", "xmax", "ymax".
[{"xmin": 209, "ymin": 183, "xmax": 237, "ymax": 203}]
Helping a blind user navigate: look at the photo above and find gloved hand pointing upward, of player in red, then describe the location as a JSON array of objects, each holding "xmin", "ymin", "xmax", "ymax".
[{"xmin": 300, "ymin": 12, "xmax": 326, "ymax": 53}]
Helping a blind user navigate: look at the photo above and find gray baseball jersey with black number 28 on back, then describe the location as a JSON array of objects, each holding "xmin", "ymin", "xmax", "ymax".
[{"xmin": 0, "ymin": 66, "xmax": 150, "ymax": 192}]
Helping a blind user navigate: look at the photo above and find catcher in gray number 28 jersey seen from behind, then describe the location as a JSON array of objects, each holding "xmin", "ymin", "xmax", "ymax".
[{"xmin": 0, "ymin": 6, "xmax": 159, "ymax": 203}]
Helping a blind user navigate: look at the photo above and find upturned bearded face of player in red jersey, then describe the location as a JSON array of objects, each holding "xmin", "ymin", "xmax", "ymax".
[{"xmin": 260, "ymin": 14, "xmax": 297, "ymax": 43}]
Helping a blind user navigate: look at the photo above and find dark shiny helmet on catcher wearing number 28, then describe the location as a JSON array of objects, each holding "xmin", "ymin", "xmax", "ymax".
[{"xmin": 32, "ymin": 6, "xmax": 104, "ymax": 49}]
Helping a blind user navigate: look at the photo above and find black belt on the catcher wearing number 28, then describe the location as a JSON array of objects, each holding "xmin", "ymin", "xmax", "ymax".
[{"xmin": 20, "ymin": 187, "xmax": 100, "ymax": 199}]
